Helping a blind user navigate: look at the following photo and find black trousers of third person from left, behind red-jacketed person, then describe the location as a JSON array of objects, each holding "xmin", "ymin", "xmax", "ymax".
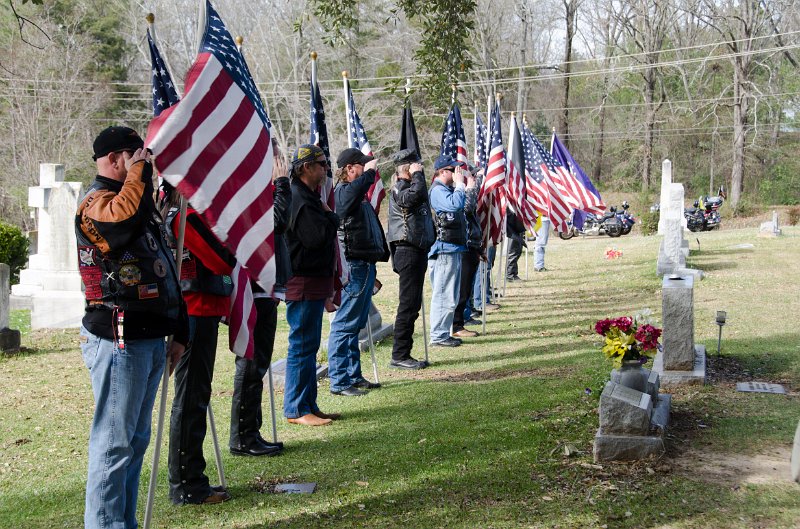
[{"xmin": 229, "ymin": 298, "xmax": 278, "ymax": 448}]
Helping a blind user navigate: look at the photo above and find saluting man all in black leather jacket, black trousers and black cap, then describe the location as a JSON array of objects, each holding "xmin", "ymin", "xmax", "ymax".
[{"xmin": 387, "ymin": 149, "xmax": 436, "ymax": 369}]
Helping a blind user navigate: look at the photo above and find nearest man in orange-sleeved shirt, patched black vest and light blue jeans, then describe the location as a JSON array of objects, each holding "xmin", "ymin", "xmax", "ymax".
[{"xmin": 75, "ymin": 127, "xmax": 189, "ymax": 529}]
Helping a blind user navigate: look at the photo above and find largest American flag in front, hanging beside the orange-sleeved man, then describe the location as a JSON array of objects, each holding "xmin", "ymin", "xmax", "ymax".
[{"xmin": 145, "ymin": 2, "xmax": 275, "ymax": 292}]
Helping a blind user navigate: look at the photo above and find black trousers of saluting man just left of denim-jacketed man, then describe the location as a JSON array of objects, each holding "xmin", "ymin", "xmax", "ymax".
[{"xmin": 392, "ymin": 245, "xmax": 428, "ymax": 361}]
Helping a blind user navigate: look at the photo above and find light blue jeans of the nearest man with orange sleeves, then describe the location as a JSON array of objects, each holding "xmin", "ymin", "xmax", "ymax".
[{"xmin": 81, "ymin": 328, "xmax": 166, "ymax": 529}]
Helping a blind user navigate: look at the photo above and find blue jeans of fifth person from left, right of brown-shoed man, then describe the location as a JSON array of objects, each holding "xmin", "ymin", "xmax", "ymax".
[{"xmin": 328, "ymin": 260, "xmax": 375, "ymax": 391}]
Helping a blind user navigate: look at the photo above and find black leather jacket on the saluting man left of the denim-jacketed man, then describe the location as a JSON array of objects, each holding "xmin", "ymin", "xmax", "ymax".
[{"xmin": 388, "ymin": 171, "xmax": 436, "ymax": 251}]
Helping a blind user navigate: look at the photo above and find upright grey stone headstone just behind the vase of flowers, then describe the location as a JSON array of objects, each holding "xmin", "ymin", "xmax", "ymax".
[{"xmin": 661, "ymin": 275, "xmax": 695, "ymax": 371}]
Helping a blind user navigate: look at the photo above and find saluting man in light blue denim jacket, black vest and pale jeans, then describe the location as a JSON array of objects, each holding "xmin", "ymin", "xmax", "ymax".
[{"xmin": 428, "ymin": 155, "xmax": 475, "ymax": 347}]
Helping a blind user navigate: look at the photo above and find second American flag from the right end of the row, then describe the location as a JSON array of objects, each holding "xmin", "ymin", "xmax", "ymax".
[{"xmin": 525, "ymin": 129, "xmax": 574, "ymax": 230}]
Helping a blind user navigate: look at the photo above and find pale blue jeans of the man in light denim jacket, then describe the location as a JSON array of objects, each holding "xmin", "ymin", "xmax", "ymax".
[{"xmin": 428, "ymin": 253, "xmax": 461, "ymax": 343}]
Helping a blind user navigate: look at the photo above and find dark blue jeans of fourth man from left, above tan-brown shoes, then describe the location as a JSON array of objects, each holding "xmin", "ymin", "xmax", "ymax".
[{"xmin": 283, "ymin": 299, "xmax": 325, "ymax": 419}]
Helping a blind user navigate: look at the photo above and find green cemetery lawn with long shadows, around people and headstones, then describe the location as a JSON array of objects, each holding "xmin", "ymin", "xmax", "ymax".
[{"xmin": 0, "ymin": 228, "xmax": 800, "ymax": 528}]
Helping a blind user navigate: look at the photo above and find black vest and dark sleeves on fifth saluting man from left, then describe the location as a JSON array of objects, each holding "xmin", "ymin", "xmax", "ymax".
[{"xmin": 334, "ymin": 169, "xmax": 389, "ymax": 263}]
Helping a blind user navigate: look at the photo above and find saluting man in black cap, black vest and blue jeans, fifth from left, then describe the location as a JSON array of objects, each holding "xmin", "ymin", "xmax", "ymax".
[{"xmin": 328, "ymin": 148, "xmax": 389, "ymax": 397}]
